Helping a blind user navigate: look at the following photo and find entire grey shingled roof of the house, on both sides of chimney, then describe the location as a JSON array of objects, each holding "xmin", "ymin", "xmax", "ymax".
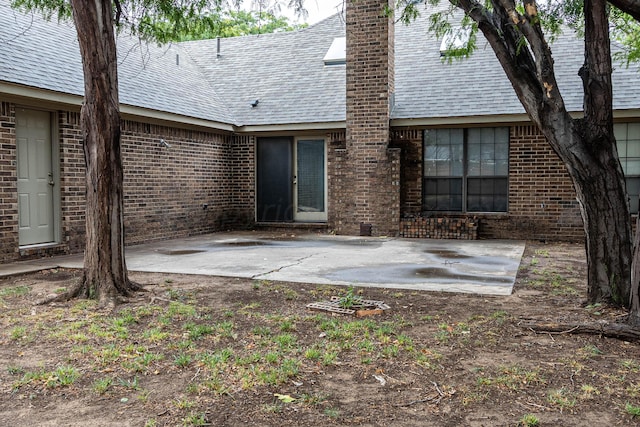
[{"xmin": 0, "ymin": 0, "xmax": 640, "ymax": 128}]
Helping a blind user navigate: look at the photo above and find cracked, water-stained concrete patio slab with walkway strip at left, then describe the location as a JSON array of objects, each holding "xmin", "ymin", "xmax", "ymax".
[{"xmin": 0, "ymin": 232, "xmax": 525, "ymax": 295}]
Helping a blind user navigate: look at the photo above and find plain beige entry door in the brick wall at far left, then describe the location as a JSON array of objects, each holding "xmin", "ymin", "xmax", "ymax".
[{"xmin": 16, "ymin": 109, "xmax": 54, "ymax": 246}]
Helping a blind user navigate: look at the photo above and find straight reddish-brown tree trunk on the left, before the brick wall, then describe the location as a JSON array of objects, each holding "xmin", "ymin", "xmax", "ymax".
[{"xmin": 70, "ymin": 0, "xmax": 137, "ymax": 305}]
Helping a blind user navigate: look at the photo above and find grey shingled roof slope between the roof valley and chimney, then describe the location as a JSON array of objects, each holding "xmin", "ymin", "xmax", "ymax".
[{"xmin": 181, "ymin": 15, "xmax": 346, "ymax": 125}]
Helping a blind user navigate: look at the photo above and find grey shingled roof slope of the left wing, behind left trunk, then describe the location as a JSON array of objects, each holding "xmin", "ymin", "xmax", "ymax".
[{"xmin": 0, "ymin": 0, "xmax": 233, "ymax": 123}]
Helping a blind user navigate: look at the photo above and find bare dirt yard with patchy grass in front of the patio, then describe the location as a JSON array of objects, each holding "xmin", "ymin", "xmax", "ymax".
[{"xmin": 0, "ymin": 242, "xmax": 640, "ymax": 426}]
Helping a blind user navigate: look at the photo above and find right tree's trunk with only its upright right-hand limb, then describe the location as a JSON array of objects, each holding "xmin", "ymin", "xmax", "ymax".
[{"xmin": 570, "ymin": 0, "xmax": 632, "ymax": 307}]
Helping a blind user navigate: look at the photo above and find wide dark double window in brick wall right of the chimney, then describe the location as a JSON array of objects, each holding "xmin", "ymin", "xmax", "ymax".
[{"xmin": 422, "ymin": 127, "xmax": 509, "ymax": 212}]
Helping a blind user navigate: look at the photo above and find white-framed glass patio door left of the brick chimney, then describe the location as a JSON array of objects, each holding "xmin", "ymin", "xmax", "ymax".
[{"xmin": 293, "ymin": 138, "xmax": 327, "ymax": 221}]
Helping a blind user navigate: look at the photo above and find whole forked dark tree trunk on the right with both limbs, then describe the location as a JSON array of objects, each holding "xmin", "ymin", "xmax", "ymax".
[{"xmin": 450, "ymin": 0, "xmax": 632, "ymax": 307}]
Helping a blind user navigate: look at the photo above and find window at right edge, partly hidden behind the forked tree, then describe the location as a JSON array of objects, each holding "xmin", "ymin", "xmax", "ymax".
[{"xmin": 613, "ymin": 123, "xmax": 640, "ymax": 213}]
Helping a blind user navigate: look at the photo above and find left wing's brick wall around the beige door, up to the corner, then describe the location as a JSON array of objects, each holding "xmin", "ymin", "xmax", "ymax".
[{"xmin": 0, "ymin": 102, "xmax": 255, "ymax": 262}]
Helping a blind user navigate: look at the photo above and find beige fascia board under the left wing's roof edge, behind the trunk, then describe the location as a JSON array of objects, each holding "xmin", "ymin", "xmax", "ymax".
[{"xmin": 0, "ymin": 82, "xmax": 235, "ymax": 132}]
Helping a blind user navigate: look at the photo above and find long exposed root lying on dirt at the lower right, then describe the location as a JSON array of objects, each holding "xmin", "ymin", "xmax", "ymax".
[{"xmin": 520, "ymin": 319, "xmax": 640, "ymax": 342}]
